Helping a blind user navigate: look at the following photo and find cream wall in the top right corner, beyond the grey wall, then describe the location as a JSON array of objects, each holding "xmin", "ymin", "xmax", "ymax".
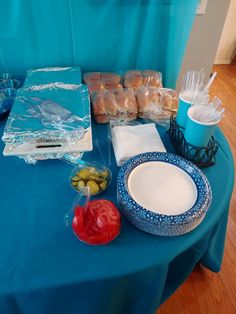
[{"xmin": 214, "ymin": 0, "xmax": 236, "ymax": 64}]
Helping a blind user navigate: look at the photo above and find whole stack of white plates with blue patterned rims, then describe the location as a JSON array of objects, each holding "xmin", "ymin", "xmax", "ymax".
[{"xmin": 118, "ymin": 152, "xmax": 212, "ymax": 236}]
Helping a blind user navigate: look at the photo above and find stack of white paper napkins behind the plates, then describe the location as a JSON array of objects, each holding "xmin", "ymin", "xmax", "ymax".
[{"xmin": 111, "ymin": 123, "xmax": 166, "ymax": 167}]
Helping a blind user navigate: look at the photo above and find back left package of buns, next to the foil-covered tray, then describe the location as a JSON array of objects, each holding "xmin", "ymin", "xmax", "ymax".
[{"xmin": 84, "ymin": 72, "xmax": 122, "ymax": 94}]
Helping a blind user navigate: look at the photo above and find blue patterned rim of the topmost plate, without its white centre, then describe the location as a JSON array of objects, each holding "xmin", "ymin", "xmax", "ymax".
[{"xmin": 117, "ymin": 152, "xmax": 212, "ymax": 224}]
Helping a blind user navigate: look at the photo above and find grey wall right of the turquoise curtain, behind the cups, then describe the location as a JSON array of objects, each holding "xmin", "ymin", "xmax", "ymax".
[{"xmin": 176, "ymin": 0, "xmax": 230, "ymax": 90}]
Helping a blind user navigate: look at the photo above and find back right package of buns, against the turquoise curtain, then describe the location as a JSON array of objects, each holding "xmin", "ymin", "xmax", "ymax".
[{"xmin": 124, "ymin": 70, "xmax": 162, "ymax": 89}]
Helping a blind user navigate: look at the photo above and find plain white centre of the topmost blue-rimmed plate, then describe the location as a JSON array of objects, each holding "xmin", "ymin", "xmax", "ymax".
[{"xmin": 128, "ymin": 161, "xmax": 197, "ymax": 215}]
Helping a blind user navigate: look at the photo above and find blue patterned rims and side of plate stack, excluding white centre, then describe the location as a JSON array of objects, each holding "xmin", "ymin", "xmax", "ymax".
[{"xmin": 117, "ymin": 152, "xmax": 212, "ymax": 236}]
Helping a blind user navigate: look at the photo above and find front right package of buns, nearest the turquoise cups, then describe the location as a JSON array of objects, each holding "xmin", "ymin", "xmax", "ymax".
[{"xmin": 136, "ymin": 86, "xmax": 178, "ymax": 123}]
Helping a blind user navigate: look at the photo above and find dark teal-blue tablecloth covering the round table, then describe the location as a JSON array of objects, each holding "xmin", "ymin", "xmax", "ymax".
[{"xmin": 0, "ymin": 123, "xmax": 233, "ymax": 314}]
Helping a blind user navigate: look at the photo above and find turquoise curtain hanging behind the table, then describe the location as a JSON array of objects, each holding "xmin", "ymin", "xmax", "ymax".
[{"xmin": 0, "ymin": 0, "xmax": 198, "ymax": 87}]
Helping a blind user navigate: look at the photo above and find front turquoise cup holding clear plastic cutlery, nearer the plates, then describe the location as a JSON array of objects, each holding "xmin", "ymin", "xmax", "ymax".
[{"xmin": 184, "ymin": 106, "xmax": 219, "ymax": 147}]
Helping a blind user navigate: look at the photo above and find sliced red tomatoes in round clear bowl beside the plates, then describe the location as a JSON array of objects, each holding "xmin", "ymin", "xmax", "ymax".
[{"xmin": 72, "ymin": 200, "xmax": 120, "ymax": 244}]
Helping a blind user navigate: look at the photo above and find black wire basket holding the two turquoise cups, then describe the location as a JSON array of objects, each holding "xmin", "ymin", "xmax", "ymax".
[{"xmin": 168, "ymin": 114, "xmax": 219, "ymax": 168}]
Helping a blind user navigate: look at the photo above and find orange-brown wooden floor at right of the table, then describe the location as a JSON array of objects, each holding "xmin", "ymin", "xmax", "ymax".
[{"xmin": 157, "ymin": 64, "xmax": 236, "ymax": 314}]
